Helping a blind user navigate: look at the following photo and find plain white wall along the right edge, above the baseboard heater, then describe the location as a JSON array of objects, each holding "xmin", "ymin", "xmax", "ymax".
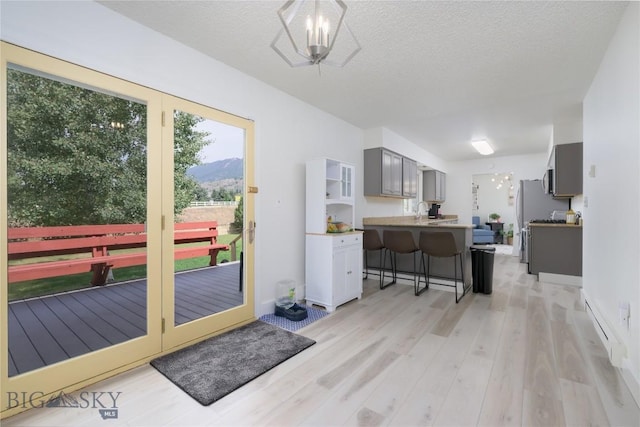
[{"xmin": 583, "ymin": 2, "xmax": 640, "ymax": 398}]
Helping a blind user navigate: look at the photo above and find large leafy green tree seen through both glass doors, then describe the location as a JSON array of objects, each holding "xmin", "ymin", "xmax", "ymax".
[{"xmin": 7, "ymin": 69, "xmax": 206, "ymax": 226}]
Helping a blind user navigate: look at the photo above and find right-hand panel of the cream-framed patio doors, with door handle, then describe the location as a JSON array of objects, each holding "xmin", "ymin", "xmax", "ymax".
[{"xmin": 162, "ymin": 95, "xmax": 255, "ymax": 350}]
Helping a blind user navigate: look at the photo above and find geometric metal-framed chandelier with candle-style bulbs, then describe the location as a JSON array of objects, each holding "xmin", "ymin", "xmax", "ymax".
[{"xmin": 271, "ymin": 0, "xmax": 361, "ymax": 67}]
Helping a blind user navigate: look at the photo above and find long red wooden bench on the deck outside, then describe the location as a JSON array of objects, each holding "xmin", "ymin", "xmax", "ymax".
[{"xmin": 8, "ymin": 221, "xmax": 229, "ymax": 285}]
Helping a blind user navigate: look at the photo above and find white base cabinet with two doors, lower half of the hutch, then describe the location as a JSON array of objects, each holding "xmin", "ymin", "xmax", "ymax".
[{"xmin": 305, "ymin": 232, "xmax": 362, "ymax": 312}]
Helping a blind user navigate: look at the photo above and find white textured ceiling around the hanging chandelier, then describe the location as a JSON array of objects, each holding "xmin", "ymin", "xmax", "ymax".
[{"xmin": 100, "ymin": 0, "xmax": 627, "ymax": 160}]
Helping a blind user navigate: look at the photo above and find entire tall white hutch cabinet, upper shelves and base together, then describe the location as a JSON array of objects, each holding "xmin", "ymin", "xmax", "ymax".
[{"xmin": 305, "ymin": 158, "xmax": 362, "ymax": 312}]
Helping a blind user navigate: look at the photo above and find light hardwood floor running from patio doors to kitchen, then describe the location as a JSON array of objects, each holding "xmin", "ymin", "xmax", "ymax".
[{"xmin": 2, "ymin": 255, "xmax": 640, "ymax": 427}]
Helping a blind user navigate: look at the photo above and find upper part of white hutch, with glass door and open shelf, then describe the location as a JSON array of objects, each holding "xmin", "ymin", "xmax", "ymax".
[{"xmin": 305, "ymin": 158, "xmax": 355, "ymax": 233}]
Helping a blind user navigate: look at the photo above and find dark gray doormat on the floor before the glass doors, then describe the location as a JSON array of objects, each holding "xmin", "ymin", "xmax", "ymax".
[{"xmin": 151, "ymin": 320, "xmax": 315, "ymax": 406}]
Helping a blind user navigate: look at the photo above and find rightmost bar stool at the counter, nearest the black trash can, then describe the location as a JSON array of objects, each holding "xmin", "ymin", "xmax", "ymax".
[{"xmin": 415, "ymin": 231, "xmax": 469, "ymax": 304}]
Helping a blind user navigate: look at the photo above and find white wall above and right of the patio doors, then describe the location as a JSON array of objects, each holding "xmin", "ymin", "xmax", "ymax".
[{"xmin": 0, "ymin": 2, "xmax": 363, "ymax": 316}]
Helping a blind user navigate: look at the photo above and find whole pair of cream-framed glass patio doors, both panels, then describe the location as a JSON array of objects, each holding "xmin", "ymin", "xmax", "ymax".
[{"xmin": 0, "ymin": 42, "xmax": 254, "ymax": 418}]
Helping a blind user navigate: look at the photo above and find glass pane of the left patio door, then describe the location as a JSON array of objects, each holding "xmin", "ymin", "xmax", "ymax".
[{"xmin": 6, "ymin": 67, "xmax": 147, "ymax": 376}]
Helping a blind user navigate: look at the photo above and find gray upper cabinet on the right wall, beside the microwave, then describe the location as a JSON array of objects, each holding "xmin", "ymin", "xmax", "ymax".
[{"xmin": 553, "ymin": 142, "xmax": 582, "ymax": 197}]
